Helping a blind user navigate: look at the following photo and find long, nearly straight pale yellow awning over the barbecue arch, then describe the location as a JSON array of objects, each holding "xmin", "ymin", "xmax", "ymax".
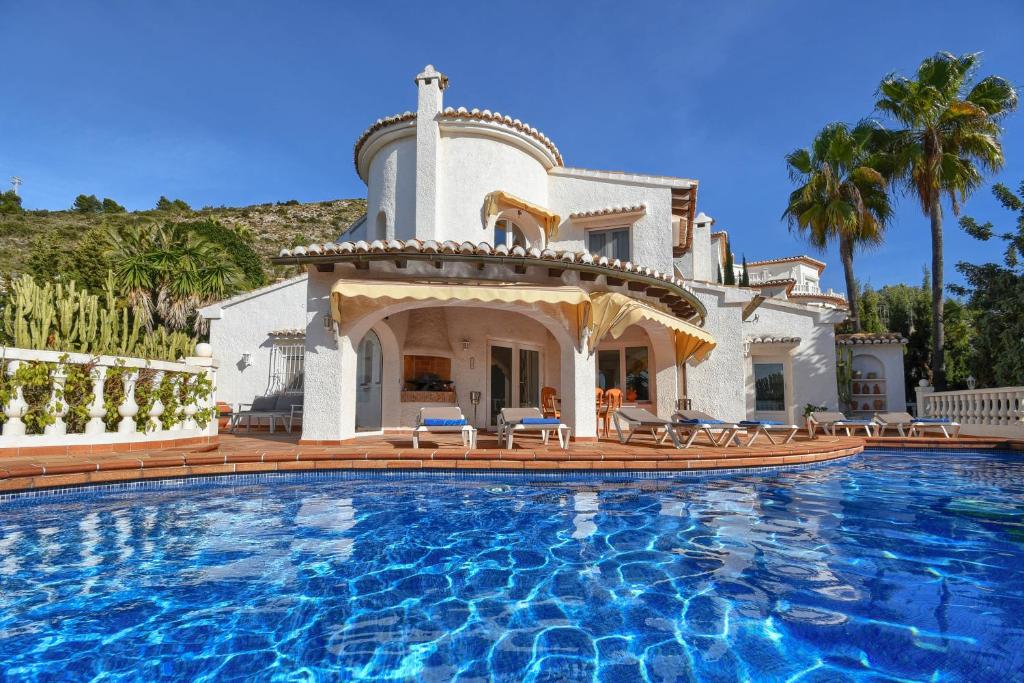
[{"xmin": 331, "ymin": 280, "xmax": 590, "ymax": 325}]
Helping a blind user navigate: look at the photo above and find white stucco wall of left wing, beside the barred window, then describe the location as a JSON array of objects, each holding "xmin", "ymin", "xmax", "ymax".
[{"xmin": 201, "ymin": 275, "xmax": 307, "ymax": 405}]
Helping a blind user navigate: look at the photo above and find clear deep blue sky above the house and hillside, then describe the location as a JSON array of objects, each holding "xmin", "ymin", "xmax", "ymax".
[{"xmin": 0, "ymin": 0, "xmax": 1024, "ymax": 289}]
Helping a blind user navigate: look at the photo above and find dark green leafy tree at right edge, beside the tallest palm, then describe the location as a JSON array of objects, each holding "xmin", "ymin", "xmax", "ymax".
[{"xmin": 950, "ymin": 181, "xmax": 1024, "ymax": 386}]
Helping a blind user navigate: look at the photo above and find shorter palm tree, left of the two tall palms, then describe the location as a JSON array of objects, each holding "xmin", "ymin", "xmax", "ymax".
[{"xmin": 782, "ymin": 121, "xmax": 892, "ymax": 332}]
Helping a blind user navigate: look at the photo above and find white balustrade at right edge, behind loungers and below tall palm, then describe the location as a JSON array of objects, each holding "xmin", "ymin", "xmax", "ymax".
[{"xmin": 918, "ymin": 386, "xmax": 1024, "ymax": 437}]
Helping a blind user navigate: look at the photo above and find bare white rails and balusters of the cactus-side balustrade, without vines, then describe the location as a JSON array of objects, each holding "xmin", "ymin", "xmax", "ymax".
[{"xmin": 0, "ymin": 346, "xmax": 217, "ymax": 449}]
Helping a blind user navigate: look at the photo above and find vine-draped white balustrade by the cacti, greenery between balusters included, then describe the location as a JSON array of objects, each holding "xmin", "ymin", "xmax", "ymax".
[{"xmin": 0, "ymin": 347, "xmax": 217, "ymax": 450}]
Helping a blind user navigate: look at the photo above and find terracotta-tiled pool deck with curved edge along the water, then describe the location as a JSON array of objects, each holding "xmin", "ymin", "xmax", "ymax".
[{"xmin": 0, "ymin": 432, "xmax": 1024, "ymax": 494}]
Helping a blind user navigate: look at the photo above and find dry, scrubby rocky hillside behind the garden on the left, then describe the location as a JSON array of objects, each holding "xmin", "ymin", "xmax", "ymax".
[{"xmin": 0, "ymin": 199, "xmax": 367, "ymax": 274}]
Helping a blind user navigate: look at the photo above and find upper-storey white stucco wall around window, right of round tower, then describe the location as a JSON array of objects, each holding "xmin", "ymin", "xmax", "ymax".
[{"xmin": 548, "ymin": 173, "xmax": 673, "ymax": 272}]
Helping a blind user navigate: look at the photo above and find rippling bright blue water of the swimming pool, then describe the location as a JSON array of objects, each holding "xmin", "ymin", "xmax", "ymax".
[{"xmin": 0, "ymin": 453, "xmax": 1024, "ymax": 681}]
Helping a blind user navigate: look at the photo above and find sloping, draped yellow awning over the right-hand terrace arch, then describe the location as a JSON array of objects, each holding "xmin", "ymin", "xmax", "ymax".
[{"xmin": 587, "ymin": 292, "xmax": 715, "ymax": 364}]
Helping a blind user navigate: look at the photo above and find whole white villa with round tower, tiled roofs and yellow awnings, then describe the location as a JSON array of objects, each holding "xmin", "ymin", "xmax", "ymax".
[{"xmin": 202, "ymin": 67, "xmax": 864, "ymax": 442}]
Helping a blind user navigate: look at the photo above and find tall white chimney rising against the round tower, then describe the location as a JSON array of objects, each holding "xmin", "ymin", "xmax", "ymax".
[{"xmin": 416, "ymin": 65, "xmax": 447, "ymax": 240}]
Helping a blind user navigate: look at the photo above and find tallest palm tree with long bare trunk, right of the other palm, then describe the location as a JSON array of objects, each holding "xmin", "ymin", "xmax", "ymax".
[{"xmin": 876, "ymin": 52, "xmax": 1017, "ymax": 388}]
